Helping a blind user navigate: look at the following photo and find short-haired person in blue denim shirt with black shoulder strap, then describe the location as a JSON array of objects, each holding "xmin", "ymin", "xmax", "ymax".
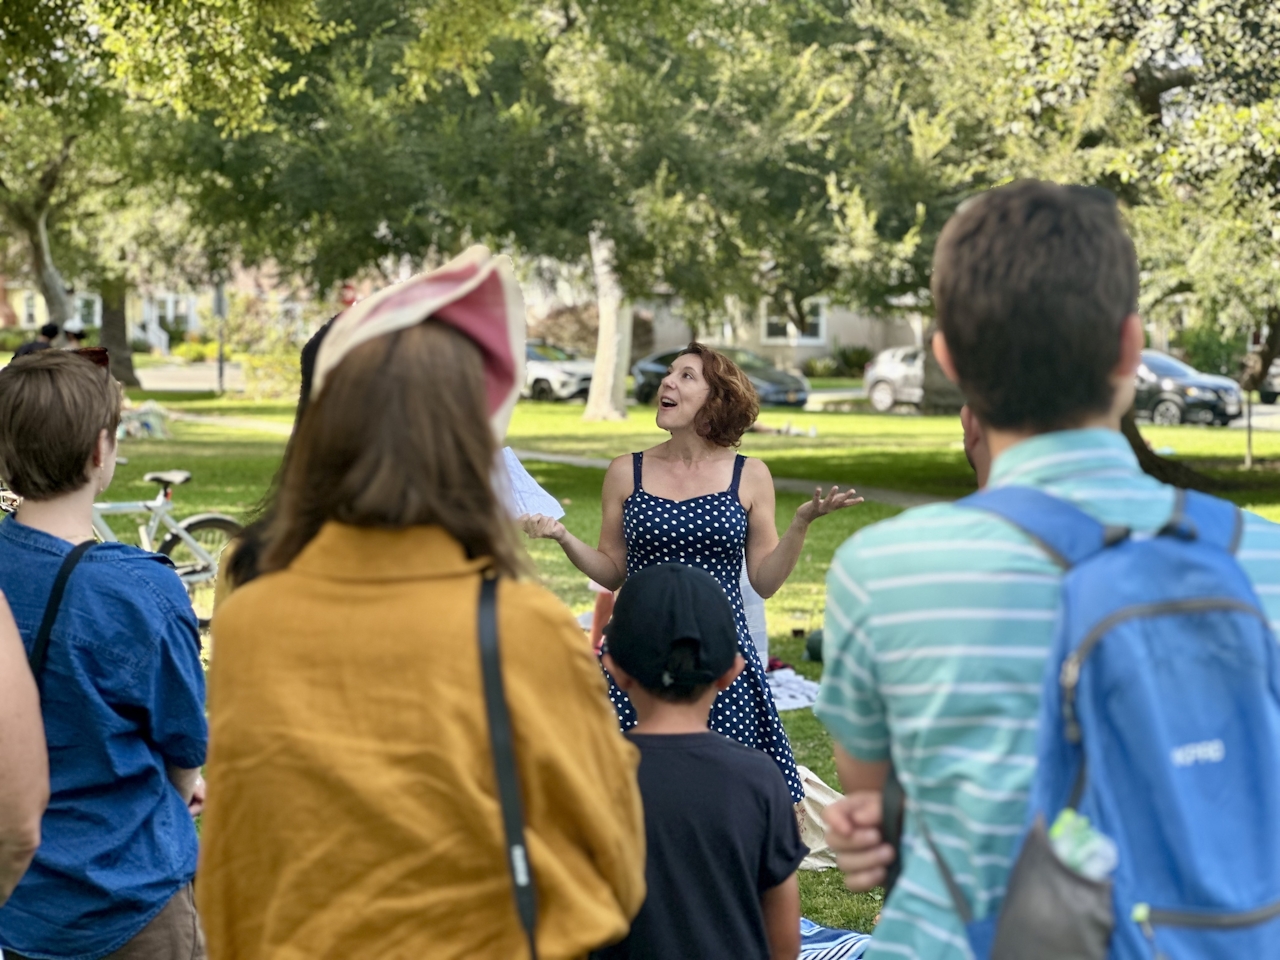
[{"xmin": 0, "ymin": 351, "xmax": 207, "ymax": 960}]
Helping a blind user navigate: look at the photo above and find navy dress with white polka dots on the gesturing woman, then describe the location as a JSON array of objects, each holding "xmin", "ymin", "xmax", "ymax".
[{"xmin": 605, "ymin": 453, "xmax": 804, "ymax": 803}]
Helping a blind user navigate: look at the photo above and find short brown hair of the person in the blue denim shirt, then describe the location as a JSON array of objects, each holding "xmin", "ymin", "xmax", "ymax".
[{"xmin": 0, "ymin": 349, "xmax": 122, "ymax": 500}]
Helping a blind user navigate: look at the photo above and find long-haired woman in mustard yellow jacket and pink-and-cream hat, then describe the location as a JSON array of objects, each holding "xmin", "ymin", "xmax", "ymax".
[{"xmin": 197, "ymin": 248, "xmax": 644, "ymax": 960}]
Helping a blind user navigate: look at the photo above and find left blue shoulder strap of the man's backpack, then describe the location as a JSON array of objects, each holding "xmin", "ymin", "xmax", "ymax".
[{"xmin": 957, "ymin": 486, "xmax": 1129, "ymax": 570}]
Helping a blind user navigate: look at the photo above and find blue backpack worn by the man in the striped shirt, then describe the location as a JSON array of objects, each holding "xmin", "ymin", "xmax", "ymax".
[{"xmin": 925, "ymin": 486, "xmax": 1280, "ymax": 960}]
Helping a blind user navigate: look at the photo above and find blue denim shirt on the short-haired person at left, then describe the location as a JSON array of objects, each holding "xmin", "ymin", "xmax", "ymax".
[{"xmin": 0, "ymin": 517, "xmax": 209, "ymax": 960}]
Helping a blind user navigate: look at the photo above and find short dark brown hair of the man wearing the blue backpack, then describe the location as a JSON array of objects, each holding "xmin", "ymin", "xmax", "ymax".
[{"xmin": 933, "ymin": 180, "xmax": 1138, "ymax": 433}]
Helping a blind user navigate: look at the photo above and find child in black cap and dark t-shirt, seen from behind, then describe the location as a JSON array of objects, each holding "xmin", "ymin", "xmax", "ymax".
[{"xmin": 593, "ymin": 563, "xmax": 808, "ymax": 960}]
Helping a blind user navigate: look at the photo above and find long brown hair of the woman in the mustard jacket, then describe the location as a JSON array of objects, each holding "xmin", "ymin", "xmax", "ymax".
[{"xmin": 262, "ymin": 320, "xmax": 526, "ymax": 576}]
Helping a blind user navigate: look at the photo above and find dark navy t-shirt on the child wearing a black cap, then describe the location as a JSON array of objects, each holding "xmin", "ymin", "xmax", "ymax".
[{"xmin": 593, "ymin": 731, "xmax": 809, "ymax": 960}]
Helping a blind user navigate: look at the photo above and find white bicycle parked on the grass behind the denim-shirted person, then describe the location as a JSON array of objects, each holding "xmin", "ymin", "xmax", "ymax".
[{"xmin": 93, "ymin": 470, "xmax": 243, "ymax": 630}]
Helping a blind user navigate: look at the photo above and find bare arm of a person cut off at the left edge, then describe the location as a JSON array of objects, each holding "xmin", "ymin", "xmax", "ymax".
[{"xmin": 0, "ymin": 595, "xmax": 49, "ymax": 906}]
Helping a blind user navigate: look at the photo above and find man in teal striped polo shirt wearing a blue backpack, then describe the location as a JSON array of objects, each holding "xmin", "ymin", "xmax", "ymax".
[{"xmin": 814, "ymin": 182, "xmax": 1280, "ymax": 960}]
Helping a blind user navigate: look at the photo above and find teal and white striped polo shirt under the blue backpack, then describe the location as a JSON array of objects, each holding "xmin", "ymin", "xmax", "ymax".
[{"xmin": 814, "ymin": 430, "xmax": 1280, "ymax": 960}]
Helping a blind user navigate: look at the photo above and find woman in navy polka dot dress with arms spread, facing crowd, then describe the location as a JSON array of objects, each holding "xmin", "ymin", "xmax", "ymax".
[{"xmin": 524, "ymin": 343, "xmax": 861, "ymax": 803}]
